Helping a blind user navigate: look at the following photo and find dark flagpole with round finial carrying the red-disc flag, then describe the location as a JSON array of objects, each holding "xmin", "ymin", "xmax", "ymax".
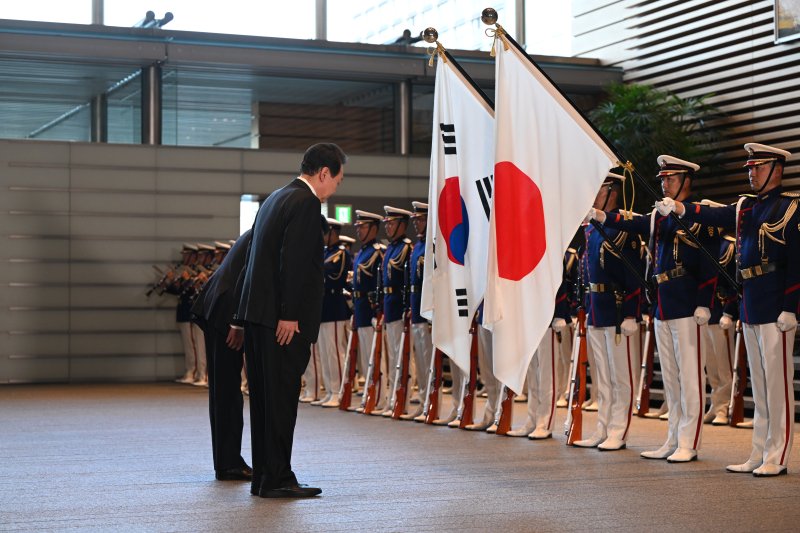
[{"xmin": 481, "ymin": 7, "xmax": 741, "ymax": 292}]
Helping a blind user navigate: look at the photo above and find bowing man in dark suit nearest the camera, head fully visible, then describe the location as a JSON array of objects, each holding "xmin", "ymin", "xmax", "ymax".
[{"xmin": 237, "ymin": 143, "xmax": 347, "ymax": 498}]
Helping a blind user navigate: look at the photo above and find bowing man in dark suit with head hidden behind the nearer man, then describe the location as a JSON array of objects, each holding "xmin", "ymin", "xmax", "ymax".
[{"xmin": 192, "ymin": 230, "xmax": 253, "ymax": 481}]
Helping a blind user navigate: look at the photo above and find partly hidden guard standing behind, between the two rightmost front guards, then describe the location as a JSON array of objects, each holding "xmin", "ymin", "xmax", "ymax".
[{"xmin": 703, "ymin": 229, "xmax": 739, "ymax": 426}]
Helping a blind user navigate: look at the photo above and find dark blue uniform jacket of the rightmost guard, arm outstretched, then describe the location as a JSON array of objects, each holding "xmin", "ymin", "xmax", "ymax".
[{"xmin": 684, "ymin": 187, "xmax": 800, "ymax": 324}]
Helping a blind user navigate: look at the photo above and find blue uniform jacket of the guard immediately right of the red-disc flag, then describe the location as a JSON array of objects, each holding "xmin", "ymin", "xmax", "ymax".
[{"xmin": 582, "ymin": 211, "xmax": 644, "ymax": 328}]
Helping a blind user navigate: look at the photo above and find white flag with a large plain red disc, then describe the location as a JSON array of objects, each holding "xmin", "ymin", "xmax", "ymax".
[{"xmin": 483, "ymin": 36, "xmax": 616, "ymax": 393}]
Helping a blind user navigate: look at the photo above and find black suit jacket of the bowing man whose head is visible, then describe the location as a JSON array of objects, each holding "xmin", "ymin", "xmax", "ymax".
[{"xmin": 237, "ymin": 179, "xmax": 324, "ymax": 343}]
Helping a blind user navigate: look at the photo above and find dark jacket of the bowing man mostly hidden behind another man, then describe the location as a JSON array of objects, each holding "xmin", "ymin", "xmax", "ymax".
[{"xmin": 192, "ymin": 229, "xmax": 253, "ymax": 331}]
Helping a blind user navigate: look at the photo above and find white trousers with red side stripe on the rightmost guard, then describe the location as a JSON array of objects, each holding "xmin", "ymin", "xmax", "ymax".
[{"xmin": 744, "ymin": 322, "xmax": 797, "ymax": 466}]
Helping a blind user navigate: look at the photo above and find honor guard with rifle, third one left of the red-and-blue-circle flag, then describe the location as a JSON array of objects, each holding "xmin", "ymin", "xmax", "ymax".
[{"xmin": 352, "ymin": 209, "xmax": 383, "ymax": 407}]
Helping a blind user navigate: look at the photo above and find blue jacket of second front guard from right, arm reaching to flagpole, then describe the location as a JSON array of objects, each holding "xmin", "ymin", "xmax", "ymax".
[{"xmin": 605, "ymin": 199, "xmax": 719, "ymax": 320}]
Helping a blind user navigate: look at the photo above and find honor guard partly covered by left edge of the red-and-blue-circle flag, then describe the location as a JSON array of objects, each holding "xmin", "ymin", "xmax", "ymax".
[{"xmin": 401, "ymin": 202, "xmax": 433, "ymax": 420}]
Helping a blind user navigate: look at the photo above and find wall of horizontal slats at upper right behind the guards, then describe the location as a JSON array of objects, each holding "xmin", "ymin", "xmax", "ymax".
[{"xmin": 573, "ymin": 0, "xmax": 800, "ymax": 201}]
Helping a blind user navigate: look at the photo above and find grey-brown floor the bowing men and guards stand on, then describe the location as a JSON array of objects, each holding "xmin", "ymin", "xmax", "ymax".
[{"xmin": 0, "ymin": 384, "xmax": 800, "ymax": 532}]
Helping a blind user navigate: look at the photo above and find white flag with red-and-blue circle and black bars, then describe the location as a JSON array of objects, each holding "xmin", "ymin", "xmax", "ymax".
[{"xmin": 421, "ymin": 55, "xmax": 494, "ymax": 372}]
